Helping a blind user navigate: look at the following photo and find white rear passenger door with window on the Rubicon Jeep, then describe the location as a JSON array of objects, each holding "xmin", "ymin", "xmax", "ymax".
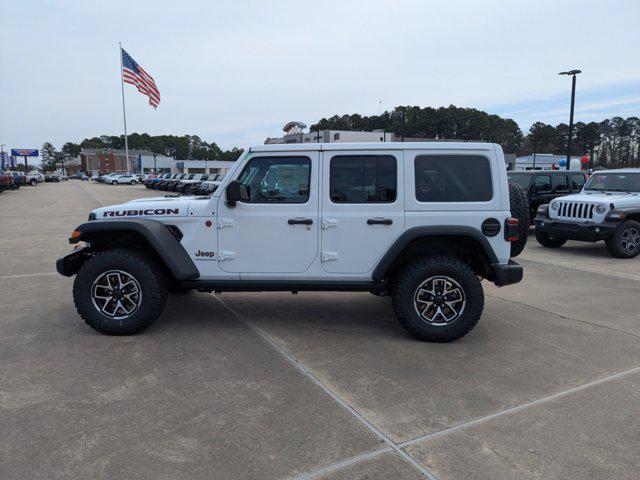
[{"xmin": 321, "ymin": 150, "xmax": 404, "ymax": 274}]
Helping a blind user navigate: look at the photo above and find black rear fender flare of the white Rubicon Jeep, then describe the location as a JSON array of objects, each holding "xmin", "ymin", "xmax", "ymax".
[{"xmin": 371, "ymin": 225, "xmax": 499, "ymax": 282}]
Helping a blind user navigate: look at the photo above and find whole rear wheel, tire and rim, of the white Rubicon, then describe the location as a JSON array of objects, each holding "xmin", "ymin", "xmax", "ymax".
[{"xmin": 393, "ymin": 255, "xmax": 484, "ymax": 342}]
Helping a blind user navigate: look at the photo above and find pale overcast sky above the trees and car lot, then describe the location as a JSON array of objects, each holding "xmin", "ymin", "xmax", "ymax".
[{"xmin": 0, "ymin": 0, "xmax": 640, "ymax": 153}]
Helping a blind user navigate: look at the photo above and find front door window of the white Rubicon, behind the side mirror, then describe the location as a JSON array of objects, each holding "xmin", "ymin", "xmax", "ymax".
[{"xmin": 238, "ymin": 157, "xmax": 311, "ymax": 203}]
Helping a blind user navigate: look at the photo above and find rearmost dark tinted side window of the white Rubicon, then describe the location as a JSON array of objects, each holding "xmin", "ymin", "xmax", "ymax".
[{"xmin": 415, "ymin": 155, "xmax": 493, "ymax": 202}]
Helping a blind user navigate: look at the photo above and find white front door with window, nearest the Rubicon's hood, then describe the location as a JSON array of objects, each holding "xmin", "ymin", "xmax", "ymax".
[{"xmin": 218, "ymin": 152, "xmax": 319, "ymax": 278}]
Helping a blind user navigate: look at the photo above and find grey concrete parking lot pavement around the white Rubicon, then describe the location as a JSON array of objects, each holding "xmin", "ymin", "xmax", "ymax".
[{"xmin": 0, "ymin": 182, "xmax": 640, "ymax": 480}]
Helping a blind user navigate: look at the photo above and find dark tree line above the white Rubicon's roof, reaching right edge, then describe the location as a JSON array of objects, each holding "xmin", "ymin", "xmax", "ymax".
[{"xmin": 310, "ymin": 105, "xmax": 640, "ymax": 168}]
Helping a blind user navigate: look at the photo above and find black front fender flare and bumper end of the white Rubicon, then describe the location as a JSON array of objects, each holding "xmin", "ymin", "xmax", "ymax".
[{"xmin": 56, "ymin": 218, "xmax": 200, "ymax": 280}]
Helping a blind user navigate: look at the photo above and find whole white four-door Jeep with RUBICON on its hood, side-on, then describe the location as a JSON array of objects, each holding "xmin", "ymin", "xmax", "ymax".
[{"xmin": 57, "ymin": 143, "xmax": 529, "ymax": 342}]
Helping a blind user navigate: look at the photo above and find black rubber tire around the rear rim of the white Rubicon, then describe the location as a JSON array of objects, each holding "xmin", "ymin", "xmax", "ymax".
[{"xmin": 392, "ymin": 255, "xmax": 484, "ymax": 343}]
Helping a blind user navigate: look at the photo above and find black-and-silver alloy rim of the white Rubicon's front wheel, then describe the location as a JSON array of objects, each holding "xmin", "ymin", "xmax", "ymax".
[{"xmin": 91, "ymin": 270, "xmax": 142, "ymax": 320}]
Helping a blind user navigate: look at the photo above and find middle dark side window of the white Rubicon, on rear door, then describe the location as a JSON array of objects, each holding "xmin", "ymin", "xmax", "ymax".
[{"xmin": 329, "ymin": 155, "xmax": 398, "ymax": 203}]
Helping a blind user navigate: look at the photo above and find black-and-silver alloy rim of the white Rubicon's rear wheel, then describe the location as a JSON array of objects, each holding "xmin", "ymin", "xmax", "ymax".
[{"xmin": 413, "ymin": 275, "xmax": 466, "ymax": 326}]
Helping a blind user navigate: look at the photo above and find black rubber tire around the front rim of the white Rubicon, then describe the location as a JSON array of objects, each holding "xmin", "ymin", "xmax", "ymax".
[{"xmin": 73, "ymin": 249, "xmax": 167, "ymax": 335}]
